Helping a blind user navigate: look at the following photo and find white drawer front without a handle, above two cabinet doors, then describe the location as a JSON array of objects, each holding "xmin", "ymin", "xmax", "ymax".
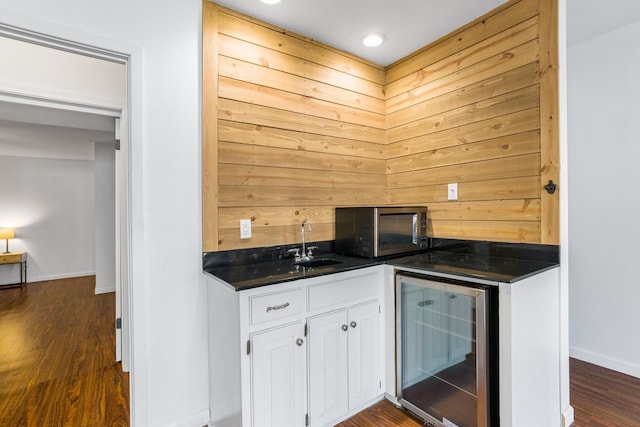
[{"xmin": 309, "ymin": 273, "xmax": 378, "ymax": 310}]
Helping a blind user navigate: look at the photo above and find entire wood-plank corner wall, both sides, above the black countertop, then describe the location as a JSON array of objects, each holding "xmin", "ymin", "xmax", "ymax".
[{"xmin": 203, "ymin": 0, "xmax": 559, "ymax": 252}]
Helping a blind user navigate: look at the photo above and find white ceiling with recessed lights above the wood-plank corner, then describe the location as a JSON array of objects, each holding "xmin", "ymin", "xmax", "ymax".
[{"xmin": 214, "ymin": 0, "xmax": 510, "ymax": 66}]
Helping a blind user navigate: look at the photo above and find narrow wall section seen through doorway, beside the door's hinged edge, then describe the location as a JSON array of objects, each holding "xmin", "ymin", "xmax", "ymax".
[{"xmin": 95, "ymin": 142, "xmax": 116, "ymax": 294}]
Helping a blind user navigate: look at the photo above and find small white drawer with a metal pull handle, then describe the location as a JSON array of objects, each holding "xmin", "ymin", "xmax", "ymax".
[{"xmin": 249, "ymin": 288, "xmax": 304, "ymax": 325}]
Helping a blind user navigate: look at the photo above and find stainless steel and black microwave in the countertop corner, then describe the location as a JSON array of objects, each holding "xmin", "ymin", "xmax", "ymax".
[{"xmin": 335, "ymin": 206, "xmax": 428, "ymax": 258}]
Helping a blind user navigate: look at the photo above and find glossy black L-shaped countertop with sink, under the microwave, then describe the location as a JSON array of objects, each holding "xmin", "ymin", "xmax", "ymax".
[{"xmin": 203, "ymin": 239, "xmax": 559, "ymax": 291}]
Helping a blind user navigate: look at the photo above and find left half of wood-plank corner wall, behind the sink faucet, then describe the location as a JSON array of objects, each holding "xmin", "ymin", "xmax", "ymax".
[{"xmin": 203, "ymin": 1, "xmax": 386, "ymax": 252}]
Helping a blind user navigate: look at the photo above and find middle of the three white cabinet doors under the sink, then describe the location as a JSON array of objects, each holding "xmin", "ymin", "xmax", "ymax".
[{"xmin": 307, "ymin": 310, "xmax": 349, "ymax": 427}]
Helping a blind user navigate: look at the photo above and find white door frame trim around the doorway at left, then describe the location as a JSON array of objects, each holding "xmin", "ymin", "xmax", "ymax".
[{"xmin": 0, "ymin": 18, "xmax": 148, "ymax": 426}]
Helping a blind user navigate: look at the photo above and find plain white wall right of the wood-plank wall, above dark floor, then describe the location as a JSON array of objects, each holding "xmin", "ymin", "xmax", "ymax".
[{"xmin": 568, "ymin": 18, "xmax": 640, "ymax": 377}]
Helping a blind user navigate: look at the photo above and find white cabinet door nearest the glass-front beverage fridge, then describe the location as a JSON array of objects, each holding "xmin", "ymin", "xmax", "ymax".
[{"xmin": 348, "ymin": 301, "xmax": 382, "ymax": 409}]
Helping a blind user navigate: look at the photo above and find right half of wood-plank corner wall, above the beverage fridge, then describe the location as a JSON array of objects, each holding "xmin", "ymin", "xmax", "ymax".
[{"xmin": 386, "ymin": 0, "xmax": 559, "ymax": 244}]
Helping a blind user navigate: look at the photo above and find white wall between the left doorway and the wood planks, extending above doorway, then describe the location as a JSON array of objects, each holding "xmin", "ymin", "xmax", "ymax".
[{"xmin": 0, "ymin": 0, "xmax": 209, "ymax": 427}]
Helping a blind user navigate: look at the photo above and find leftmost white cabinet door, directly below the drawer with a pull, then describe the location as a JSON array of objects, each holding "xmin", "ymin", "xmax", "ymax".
[{"xmin": 251, "ymin": 322, "xmax": 306, "ymax": 427}]
